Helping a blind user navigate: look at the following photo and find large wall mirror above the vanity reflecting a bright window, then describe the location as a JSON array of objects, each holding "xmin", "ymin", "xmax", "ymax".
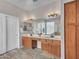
[{"xmin": 32, "ymin": 17, "xmax": 60, "ymax": 35}]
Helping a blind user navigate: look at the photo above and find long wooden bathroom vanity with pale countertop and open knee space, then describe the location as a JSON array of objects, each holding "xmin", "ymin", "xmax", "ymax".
[{"xmin": 22, "ymin": 36, "xmax": 61, "ymax": 57}]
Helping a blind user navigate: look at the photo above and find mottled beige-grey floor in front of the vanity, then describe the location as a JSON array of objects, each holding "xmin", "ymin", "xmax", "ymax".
[{"xmin": 0, "ymin": 48, "xmax": 60, "ymax": 59}]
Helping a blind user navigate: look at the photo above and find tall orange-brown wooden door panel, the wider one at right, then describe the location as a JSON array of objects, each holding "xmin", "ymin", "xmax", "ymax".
[{"xmin": 64, "ymin": 2, "xmax": 76, "ymax": 59}]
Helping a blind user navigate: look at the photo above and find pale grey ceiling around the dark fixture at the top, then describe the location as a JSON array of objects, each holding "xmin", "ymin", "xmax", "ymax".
[{"xmin": 6, "ymin": 0, "xmax": 57, "ymax": 11}]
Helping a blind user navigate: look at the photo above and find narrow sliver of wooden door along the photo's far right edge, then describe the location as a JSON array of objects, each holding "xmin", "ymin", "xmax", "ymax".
[{"xmin": 77, "ymin": 0, "xmax": 79, "ymax": 59}]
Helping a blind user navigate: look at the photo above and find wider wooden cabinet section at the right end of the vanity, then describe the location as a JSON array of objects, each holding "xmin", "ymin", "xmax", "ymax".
[{"xmin": 41, "ymin": 39, "xmax": 61, "ymax": 57}]
